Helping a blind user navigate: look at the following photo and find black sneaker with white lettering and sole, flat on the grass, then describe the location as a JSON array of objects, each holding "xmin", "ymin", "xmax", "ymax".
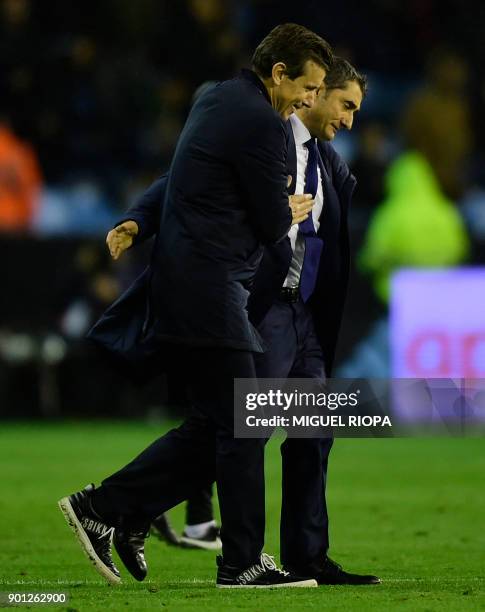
[{"xmin": 216, "ymin": 553, "xmax": 318, "ymax": 589}]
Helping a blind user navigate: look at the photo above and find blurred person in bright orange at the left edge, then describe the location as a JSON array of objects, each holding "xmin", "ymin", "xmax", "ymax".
[{"xmin": 0, "ymin": 118, "xmax": 42, "ymax": 232}]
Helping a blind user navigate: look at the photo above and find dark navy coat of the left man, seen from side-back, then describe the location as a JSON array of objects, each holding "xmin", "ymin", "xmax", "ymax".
[{"xmin": 88, "ymin": 70, "xmax": 291, "ymax": 362}]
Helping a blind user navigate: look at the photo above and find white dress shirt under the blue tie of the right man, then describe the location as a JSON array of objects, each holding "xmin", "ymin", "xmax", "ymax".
[{"xmin": 283, "ymin": 113, "xmax": 323, "ymax": 287}]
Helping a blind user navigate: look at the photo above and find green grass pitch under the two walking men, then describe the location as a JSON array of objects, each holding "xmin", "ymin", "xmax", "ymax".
[{"xmin": 0, "ymin": 422, "xmax": 485, "ymax": 612}]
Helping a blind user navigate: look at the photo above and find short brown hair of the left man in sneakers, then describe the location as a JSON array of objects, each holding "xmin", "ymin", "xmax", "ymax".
[{"xmin": 252, "ymin": 23, "xmax": 333, "ymax": 79}]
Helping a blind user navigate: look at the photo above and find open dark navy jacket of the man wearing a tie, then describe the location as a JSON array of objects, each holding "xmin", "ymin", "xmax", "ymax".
[{"xmin": 91, "ymin": 109, "xmax": 356, "ymax": 376}]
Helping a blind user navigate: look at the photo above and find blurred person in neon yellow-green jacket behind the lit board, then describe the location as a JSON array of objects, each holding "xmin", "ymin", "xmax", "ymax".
[{"xmin": 338, "ymin": 151, "xmax": 470, "ymax": 378}]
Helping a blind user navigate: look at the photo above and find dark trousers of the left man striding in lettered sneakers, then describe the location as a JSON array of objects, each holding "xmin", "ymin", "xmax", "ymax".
[{"xmin": 93, "ymin": 347, "xmax": 265, "ymax": 568}]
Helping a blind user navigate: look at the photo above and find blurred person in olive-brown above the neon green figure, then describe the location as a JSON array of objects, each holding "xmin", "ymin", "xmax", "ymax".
[{"xmin": 402, "ymin": 48, "xmax": 473, "ymax": 200}]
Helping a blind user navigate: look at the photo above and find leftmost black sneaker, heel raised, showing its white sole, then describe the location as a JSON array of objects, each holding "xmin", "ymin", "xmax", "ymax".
[{"xmin": 58, "ymin": 485, "xmax": 121, "ymax": 584}]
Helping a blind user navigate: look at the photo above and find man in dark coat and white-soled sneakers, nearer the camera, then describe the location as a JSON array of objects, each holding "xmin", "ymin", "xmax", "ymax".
[{"xmin": 55, "ymin": 24, "xmax": 332, "ymax": 587}]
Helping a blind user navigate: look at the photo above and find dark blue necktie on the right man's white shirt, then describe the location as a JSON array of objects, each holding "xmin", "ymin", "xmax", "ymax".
[{"xmin": 298, "ymin": 138, "xmax": 323, "ymax": 302}]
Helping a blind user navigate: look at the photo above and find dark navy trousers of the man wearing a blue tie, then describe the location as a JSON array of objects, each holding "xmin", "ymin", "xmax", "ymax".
[{"xmin": 255, "ymin": 300, "xmax": 333, "ymax": 574}]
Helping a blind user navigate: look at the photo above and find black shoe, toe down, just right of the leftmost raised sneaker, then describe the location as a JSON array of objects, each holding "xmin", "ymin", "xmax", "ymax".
[{"xmin": 113, "ymin": 519, "xmax": 150, "ymax": 581}]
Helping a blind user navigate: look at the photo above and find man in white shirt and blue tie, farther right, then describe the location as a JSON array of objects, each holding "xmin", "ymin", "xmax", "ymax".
[{"xmin": 102, "ymin": 58, "xmax": 379, "ymax": 584}]
